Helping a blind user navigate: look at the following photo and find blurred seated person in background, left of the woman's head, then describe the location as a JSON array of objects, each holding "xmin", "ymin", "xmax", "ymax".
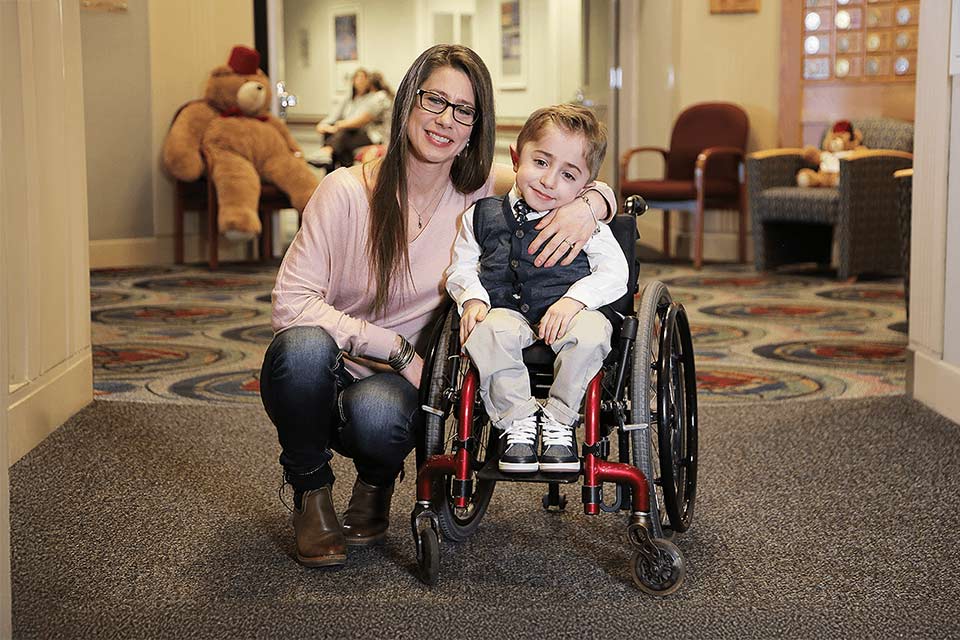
[{"xmin": 317, "ymin": 69, "xmax": 393, "ymax": 171}]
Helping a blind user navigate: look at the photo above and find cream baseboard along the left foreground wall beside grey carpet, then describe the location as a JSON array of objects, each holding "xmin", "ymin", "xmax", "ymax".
[{"xmin": 7, "ymin": 347, "xmax": 93, "ymax": 465}]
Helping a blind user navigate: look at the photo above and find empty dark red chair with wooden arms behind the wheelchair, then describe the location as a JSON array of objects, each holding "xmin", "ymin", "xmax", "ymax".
[{"xmin": 620, "ymin": 102, "xmax": 750, "ymax": 269}]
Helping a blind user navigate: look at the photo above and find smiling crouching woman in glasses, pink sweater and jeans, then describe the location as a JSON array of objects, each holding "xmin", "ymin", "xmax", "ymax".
[{"xmin": 260, "ymin": 45, "xmax": 613, "ymax": 566}]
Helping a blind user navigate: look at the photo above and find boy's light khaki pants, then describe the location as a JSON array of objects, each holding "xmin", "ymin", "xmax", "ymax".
[{"xmin": 464, "ymin": 308, "xmax": 613, "ymax": 429}]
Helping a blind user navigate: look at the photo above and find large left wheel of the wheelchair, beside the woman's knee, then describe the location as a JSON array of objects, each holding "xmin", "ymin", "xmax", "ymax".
[{"xmin": 418, "ymin": 308, "xmax": 496, "ymax": 542}]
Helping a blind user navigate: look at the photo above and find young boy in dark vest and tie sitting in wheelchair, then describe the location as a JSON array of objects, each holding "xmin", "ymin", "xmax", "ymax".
[{"xmin": 447, "ymin": 105, "xmax": 628, "ymax": 473}]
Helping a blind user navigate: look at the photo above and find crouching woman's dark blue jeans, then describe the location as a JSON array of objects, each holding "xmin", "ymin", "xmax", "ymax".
[{"xmin": 260, "ymin": 327, "xmax": 418, "ymax": 491}]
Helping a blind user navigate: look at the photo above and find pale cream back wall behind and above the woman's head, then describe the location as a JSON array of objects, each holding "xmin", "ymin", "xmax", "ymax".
[{"xmin": 283, "ymin": 0, "xmax": 582, "ymax": 121}]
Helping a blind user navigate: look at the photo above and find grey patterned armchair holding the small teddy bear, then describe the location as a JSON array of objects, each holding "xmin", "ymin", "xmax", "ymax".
[{"xmin": 747, "ymin": 118, "xmax": 913, "ymax": 279}]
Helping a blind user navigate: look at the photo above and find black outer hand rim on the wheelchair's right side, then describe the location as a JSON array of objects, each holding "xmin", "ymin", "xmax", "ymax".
[{"xmin": 657, "ymin": 303, "xmax": 697, "ymax": 532}]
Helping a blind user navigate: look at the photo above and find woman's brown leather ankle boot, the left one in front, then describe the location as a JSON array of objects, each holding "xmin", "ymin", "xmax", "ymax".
[{"xmin": 293, "ymin": 487, "xmax": 347, "ymax": 567}]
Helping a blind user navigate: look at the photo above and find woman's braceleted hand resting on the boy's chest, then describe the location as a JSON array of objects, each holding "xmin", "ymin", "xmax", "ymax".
[{"xmin": 528, "ymin": 191, "xmax": 604, "ymax": 267}]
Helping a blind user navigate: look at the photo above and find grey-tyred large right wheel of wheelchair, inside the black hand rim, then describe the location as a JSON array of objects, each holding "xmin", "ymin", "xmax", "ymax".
[{"xmin": 630, "ymin": 281, "xmax": 673, "ymax": 538}]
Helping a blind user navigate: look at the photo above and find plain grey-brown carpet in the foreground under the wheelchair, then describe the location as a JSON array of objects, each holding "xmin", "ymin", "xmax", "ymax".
[{"xmin": 11, "ymin": 397, "xmax": 960, "ymax": 639}]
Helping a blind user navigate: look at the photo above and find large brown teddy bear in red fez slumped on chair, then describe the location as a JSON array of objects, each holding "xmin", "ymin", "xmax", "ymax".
[{"xmin": 163, "ymin": 46, "xmax": 317, "ymax": 238}]
